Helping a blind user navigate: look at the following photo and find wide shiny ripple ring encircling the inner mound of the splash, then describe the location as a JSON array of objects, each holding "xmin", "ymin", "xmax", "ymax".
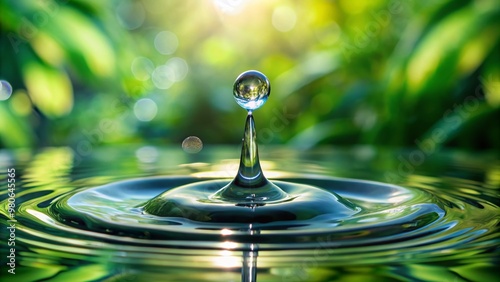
[{"xmin": 24, "ymin": 174, "xmax": 492, "ymax": 253}]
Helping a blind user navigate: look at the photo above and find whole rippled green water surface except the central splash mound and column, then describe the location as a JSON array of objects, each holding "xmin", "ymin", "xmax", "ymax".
[{"xmin": 0, "ymin": 147, "xmax": 500, "ymax": 281}]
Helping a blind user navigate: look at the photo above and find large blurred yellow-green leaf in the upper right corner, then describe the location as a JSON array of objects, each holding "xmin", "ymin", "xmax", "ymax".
[{"xmin": 404, "ymin": 6, "xmax": 500, "ymax": 99}]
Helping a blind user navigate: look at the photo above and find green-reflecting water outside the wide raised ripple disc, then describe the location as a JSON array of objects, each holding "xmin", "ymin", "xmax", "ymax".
[{"xmin": 0, "ymin": 148, "xmax": 500, "ymax": 281}]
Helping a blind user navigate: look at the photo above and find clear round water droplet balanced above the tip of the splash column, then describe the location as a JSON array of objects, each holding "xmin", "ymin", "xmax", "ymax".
[{"xmin": 233, "ymin": 70, "xmax": 271, "ymax": 111}]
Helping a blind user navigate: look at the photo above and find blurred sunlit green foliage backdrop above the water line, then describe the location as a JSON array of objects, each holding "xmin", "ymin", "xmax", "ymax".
[{"xmin": 0, "ymin": 0, "xmax": 500, "ymax": 152}]
